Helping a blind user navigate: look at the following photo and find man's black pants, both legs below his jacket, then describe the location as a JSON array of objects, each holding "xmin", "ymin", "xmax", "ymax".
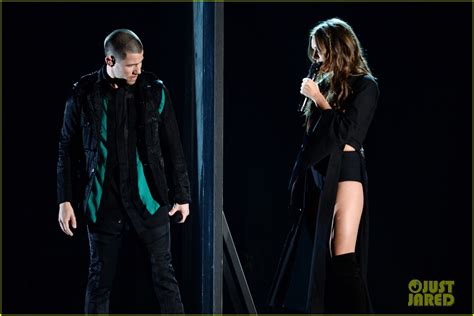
[{"xmin": 85, "ymin": 223, "xmax": 184, "ymax": 314}]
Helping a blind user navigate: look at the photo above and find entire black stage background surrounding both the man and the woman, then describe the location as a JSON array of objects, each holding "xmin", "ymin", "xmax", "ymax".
[{"xmin": 2, "ymin": 3, "xmax": 472, "ymax": 313}]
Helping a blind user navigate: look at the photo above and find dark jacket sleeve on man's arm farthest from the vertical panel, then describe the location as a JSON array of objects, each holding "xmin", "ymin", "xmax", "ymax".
[{"xmin": 56, "ymin": 93, "xmax": 80, "ymax": 204}]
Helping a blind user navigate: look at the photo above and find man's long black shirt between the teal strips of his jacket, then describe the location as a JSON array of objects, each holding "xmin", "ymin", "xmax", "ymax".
[{"xmin": 94, "ymin": 67, "xmax": 163, "ymax": 232}]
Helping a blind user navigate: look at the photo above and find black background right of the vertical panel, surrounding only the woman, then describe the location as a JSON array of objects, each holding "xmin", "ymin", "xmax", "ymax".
[{"xmin": 224, "ymin": 3, "xmax": 472, "ymax": 313}]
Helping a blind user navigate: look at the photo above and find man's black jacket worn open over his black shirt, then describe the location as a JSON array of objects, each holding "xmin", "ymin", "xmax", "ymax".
[{"xmin": 57, "ymin": 71, "xmax": 191, "ymax": 214}]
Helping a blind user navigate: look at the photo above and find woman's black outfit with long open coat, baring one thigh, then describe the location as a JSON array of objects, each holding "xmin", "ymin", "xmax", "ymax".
[{"xmin": 269, "ymin": 75, "xmax": 379, "ymax": 313}]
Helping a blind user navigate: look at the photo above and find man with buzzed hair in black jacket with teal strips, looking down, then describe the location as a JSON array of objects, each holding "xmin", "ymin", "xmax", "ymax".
[{"xmin": 57, "ymin": 29, "xmax": 191, "ymax": 313}]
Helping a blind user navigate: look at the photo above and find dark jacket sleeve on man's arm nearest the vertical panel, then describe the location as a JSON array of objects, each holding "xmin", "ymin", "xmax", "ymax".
[{"xmin": 160, "ymin": 85, "xmax": 191, "ymax": 204}]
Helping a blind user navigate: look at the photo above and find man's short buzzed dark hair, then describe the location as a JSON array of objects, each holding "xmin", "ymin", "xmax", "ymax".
[{"xmin": 104, "ymin": 29, "xmax": 143, "ymax": 59}]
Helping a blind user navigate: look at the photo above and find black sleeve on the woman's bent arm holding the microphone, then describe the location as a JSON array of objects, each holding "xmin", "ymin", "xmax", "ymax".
[{"xmin": 302, "ymin": 77, "xmax": 379, "ymax": 167}]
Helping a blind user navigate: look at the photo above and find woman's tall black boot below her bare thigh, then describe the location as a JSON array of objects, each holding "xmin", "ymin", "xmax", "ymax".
[{"xmin": 325, "ymin": 252, "xmax": 373, "ymax": 314}]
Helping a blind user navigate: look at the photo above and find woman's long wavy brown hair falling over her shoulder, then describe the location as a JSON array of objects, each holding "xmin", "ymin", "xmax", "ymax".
[{"xmin": 305, "ymin": 18, "xmax": 372, "ymax": 127}]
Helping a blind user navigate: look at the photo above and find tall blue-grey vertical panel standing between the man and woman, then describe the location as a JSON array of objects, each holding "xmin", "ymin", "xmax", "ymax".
[{"xmin": 194, "ymin": 3, "xmax": 223, "ymax": 313}]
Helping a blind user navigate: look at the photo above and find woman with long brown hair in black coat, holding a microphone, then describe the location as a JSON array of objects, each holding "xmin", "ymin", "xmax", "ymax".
[{"xmin": 270, "ymin": 18, "xmax": 379, "ymax": 313}]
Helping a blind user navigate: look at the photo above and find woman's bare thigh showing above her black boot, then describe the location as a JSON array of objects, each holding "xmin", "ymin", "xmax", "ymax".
[{"xmin": 332, "ymin": 181, "xmax": 364, "ymax": 256}]
